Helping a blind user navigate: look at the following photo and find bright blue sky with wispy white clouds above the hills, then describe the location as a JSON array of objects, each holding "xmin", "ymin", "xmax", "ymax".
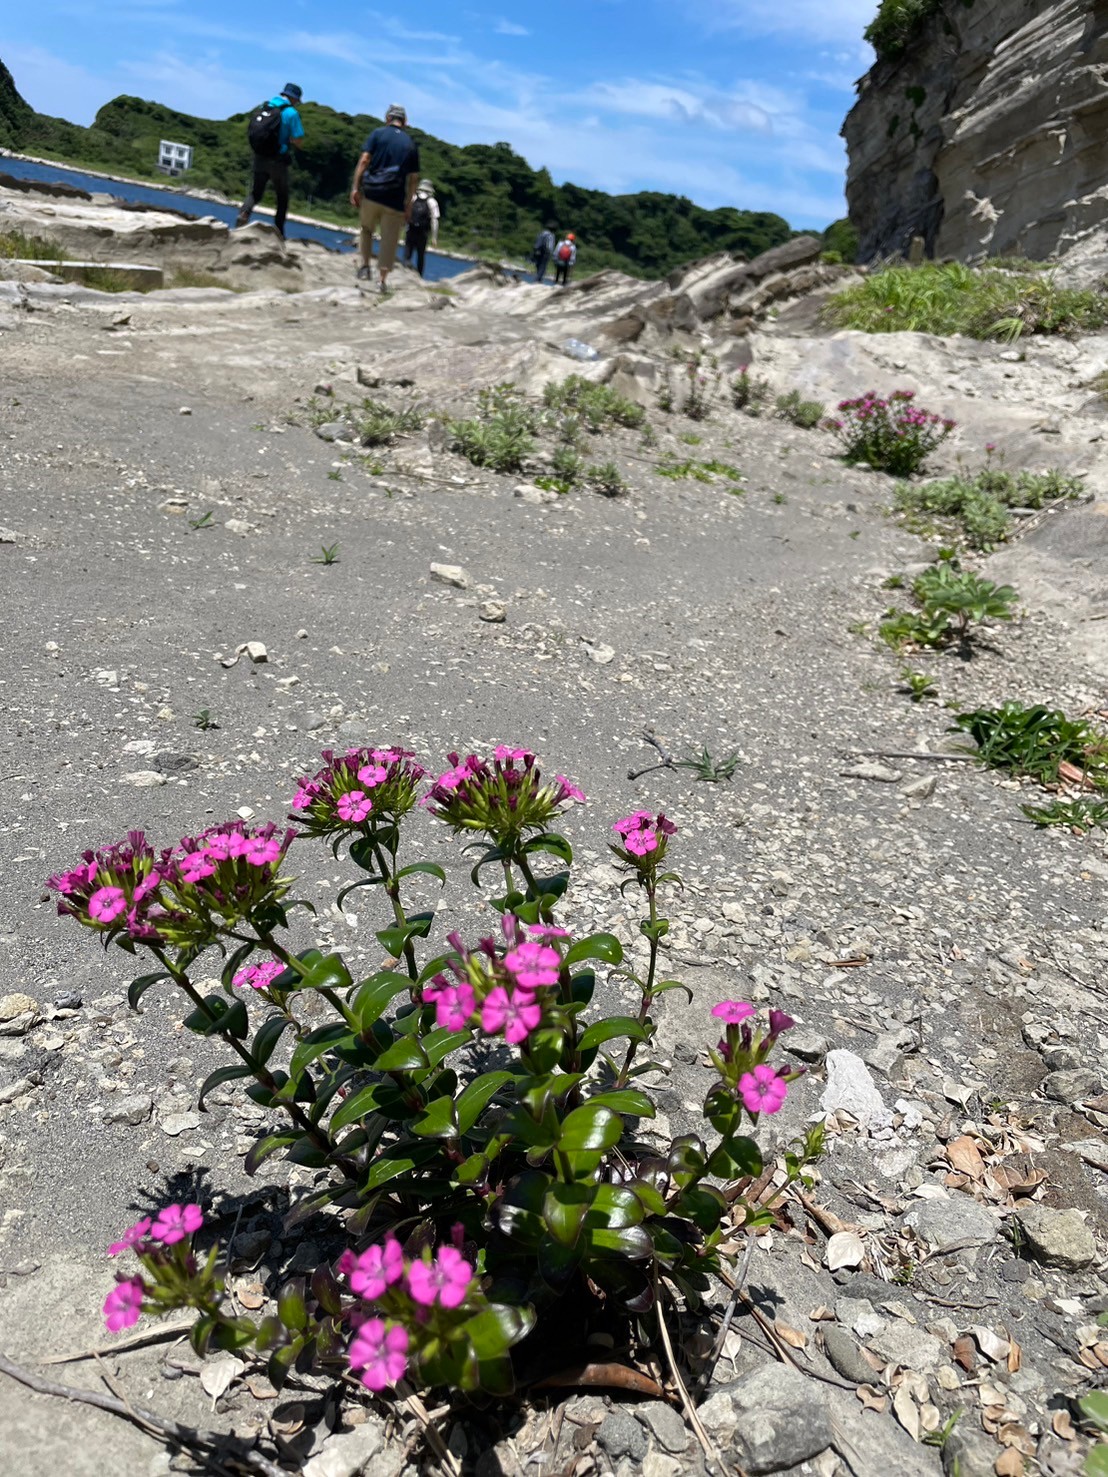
[{"xmin": 0, "ymin": 0, "xmax": 876, "ymax": 226}]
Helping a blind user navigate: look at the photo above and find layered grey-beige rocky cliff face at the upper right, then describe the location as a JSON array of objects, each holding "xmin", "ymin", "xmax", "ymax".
[{"xmin": 842, "ymin": 0, "xmax": 1108, "ymax": 261}]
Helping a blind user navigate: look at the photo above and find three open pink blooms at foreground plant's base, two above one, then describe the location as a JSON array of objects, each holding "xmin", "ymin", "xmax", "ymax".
[{"xmin": 338, "ymin": 1236, "xmax": 473, "ymax": 1391}]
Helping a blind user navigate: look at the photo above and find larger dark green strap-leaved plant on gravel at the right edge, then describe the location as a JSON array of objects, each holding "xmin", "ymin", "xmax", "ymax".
[{"xmin": 950, "ymin": 703, "xmax": 1108, "ymax": 790}]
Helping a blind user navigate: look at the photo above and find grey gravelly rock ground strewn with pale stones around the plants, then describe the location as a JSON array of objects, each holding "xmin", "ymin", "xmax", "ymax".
[{"xmin": 0, "ymin": 205, "xmax": 1108, "ymax": 1477}]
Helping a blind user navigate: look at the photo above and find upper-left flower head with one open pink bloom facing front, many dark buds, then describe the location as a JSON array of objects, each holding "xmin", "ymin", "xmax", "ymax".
[{"xmin": 293, "ymin": 747, "xmax": 427, "ymax": 836}]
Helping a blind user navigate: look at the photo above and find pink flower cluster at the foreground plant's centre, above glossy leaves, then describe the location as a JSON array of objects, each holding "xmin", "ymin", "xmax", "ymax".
[{"xmin": 423, "ymin": 913, "xmax": 569, "ymax": 1046}]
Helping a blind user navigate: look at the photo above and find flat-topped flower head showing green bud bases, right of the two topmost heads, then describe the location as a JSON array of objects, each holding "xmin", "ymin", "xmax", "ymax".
[{"xmin": 421, "ymin": 744, "xmax": 585, "ymax": 837}]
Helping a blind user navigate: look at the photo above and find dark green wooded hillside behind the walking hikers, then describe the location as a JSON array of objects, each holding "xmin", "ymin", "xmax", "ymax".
[{"xmin": 0, "ymin": 62, "xmax": 792, "ymax": 276}]
